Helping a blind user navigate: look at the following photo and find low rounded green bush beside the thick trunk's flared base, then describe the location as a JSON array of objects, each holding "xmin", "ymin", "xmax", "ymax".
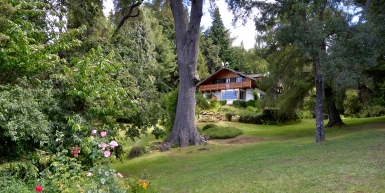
[{"xmin": 202, "ymin": 126, "xmax": 243, "ymax": 139}]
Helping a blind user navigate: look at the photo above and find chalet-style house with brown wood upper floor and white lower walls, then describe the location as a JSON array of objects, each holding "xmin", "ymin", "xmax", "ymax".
[{"xmin": 196, "ymin": 67, "xmax": 266, "ymax": 104}]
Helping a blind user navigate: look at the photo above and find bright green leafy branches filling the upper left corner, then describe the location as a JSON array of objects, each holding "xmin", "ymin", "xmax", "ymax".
[{"xmin": 0, "ymin": 1, "xmax": 83, "ymax": 84}]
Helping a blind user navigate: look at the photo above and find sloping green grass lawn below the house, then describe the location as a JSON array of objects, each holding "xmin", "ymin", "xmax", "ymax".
[{"xmin": 114, "ymin": 117, "xmax": 385, "ymax": 192}]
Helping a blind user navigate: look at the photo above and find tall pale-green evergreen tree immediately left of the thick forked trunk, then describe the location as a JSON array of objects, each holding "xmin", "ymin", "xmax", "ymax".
[{"xmin": 106, "ymin": 8, "xmax": 164, "ymax": 138}]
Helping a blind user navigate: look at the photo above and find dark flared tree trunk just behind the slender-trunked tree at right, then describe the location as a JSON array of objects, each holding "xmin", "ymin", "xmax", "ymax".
[{"xmin": 325, "ymin": 84, "xmax": 345, "ymax": 127}]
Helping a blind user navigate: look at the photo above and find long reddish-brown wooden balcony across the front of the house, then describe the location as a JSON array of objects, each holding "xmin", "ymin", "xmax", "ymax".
[{"xmin": 199, "ymin": 81, "xmax": 255, "ymax": 92}]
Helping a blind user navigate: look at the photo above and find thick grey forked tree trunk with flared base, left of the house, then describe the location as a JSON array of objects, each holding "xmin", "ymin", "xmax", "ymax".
[{"xmin": 167, "ymin": 0, "xmax": 203, "ymax": 147}]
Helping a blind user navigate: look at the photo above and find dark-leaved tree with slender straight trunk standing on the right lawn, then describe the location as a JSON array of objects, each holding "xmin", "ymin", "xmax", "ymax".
[{"xmin": 229, "ymin": 1, "xmax": 371, "ymax": 142}]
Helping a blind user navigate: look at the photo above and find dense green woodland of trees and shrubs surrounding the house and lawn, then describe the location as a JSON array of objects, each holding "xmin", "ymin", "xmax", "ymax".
[{"xmin": 0, "ymin": 0, "xmax": 385, "ymax": 192}]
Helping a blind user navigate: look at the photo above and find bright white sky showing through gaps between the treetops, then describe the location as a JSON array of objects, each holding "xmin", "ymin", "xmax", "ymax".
[{"xmin": 103, "ymin": 0, "xmax": 256, "ymax": 50}]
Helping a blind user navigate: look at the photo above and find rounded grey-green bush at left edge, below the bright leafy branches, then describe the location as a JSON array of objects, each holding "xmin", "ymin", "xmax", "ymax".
[{"xmin": 0, "ymin": 84, "xmax": 55, "ymax": 159}]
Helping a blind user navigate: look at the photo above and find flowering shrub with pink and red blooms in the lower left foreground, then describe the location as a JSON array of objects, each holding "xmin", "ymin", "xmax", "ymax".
[{"xmin": 23, "ymin": 130, "xmax": 149, "ymax": 193}]
